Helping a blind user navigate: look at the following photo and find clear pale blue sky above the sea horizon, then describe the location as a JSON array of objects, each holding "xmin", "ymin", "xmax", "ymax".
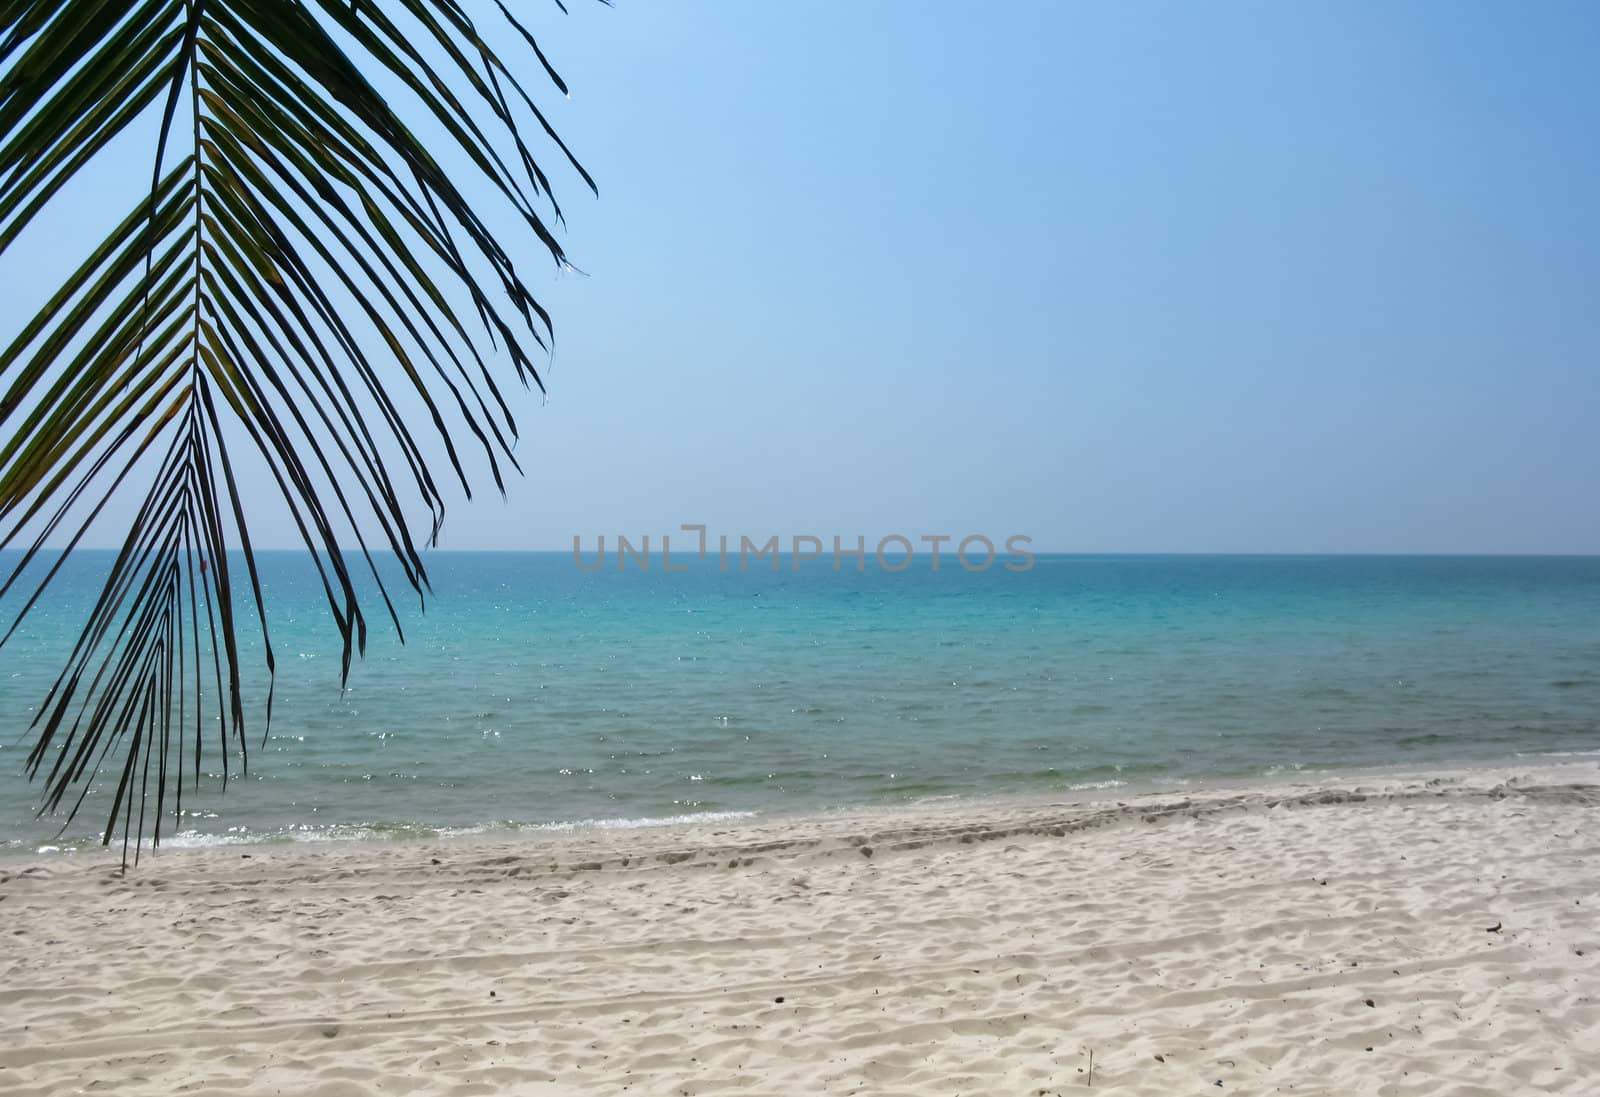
[{"xmin": 0, "ymin": 0, "xmax": 1600, "ymax": 552}]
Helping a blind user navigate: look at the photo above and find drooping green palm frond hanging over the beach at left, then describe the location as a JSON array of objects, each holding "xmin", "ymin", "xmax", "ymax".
[{"xmin": 0, "ymin": 0, "xmax": 594, "ymax": 864}]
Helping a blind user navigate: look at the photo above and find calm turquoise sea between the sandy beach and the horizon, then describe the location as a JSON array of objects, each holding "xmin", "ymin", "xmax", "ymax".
[{"xmin": 0, "ymin": 544, "xmax": 1600, "ymax": 851}]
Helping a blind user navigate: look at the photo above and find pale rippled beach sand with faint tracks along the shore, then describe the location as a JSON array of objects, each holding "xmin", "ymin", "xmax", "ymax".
[{"xmin": 0, "ymin": 763, "xmax": 1600, "ymax": 1097}]
